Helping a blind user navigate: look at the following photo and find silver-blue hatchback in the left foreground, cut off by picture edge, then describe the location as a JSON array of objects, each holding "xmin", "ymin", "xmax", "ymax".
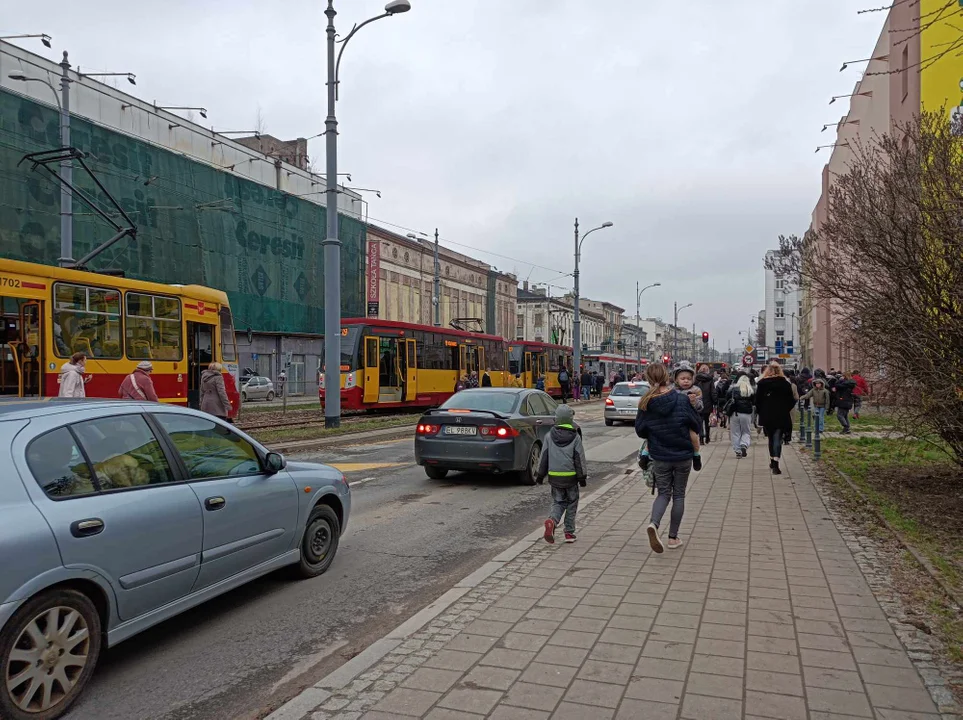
[{"xmin": 0, "ymin": 398, "xmax": 351, "ymax": 720}]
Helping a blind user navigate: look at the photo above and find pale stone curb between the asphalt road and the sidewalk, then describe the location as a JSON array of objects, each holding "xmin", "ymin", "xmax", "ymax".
[{"xmin": 265, "ymin": 461, "xmax": 635, "ymax": 720}]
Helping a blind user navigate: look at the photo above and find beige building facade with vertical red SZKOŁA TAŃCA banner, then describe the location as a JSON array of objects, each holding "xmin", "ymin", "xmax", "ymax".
[{"xmin": 366, "ymin": 225, "xmax": 518, "ymax": 340}]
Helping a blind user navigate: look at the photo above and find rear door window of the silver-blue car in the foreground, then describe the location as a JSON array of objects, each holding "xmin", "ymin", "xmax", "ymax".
[{"xmin": 73, "ymin": 415, "xmax": 174, "ymax": 490}]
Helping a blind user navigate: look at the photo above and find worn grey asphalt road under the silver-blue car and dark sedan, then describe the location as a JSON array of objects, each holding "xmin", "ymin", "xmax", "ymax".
[{"xmin": 66, "ymin": 405, "xmax": 638, "ymax": 720}]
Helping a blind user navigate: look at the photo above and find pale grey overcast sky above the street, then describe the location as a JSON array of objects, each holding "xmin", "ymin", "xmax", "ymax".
[{"xmin": 9, "ymin": 0, "xmax": 885, "ymax": 350}]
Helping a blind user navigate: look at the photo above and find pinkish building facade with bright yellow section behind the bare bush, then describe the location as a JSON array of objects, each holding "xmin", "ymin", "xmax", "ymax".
[{"xmin": 801, "ymin": 0, "xmax": 963, "ymax": 369}]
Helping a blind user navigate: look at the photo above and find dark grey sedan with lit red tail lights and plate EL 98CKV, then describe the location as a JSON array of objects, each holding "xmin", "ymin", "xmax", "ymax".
[{"xmin": 415, "ymin": 387, "xmax": 557, "ymax": 485}]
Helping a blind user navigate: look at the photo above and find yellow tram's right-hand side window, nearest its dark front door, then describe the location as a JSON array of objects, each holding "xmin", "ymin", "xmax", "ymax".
[{"xmin": 125, "ymin": 292, "xmax": 183, "ymax": 360}]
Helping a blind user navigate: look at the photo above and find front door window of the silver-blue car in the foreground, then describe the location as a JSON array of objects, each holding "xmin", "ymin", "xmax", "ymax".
[{"xmin": 154, "ymin": 413, "xmax": 261, "ymax": 480}]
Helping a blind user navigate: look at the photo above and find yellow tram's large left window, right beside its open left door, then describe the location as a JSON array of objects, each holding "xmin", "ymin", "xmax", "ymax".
[{"xmin": 53, "ymin": 283, "xmax": 123, "ymax": 360}]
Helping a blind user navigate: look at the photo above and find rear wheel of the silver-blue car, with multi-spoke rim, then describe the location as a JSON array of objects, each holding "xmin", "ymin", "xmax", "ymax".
[{"xmin": 0, "ymin": 590, "xmax": 101, "ymax": 720}]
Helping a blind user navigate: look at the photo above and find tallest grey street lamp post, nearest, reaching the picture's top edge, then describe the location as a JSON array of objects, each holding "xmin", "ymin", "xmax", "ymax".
[{"xmin": 321, "ymin": 0, "xmax": 411, "ymax": 428}]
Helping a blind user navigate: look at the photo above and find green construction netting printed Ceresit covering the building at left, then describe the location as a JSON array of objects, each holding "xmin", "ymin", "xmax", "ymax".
[{"xmin": 0, "ymin": 91, "xmax": 365, "ymax": 333}]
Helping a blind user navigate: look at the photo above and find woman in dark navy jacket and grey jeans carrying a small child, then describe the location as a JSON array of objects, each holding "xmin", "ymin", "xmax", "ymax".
[{"xmin": 635, "ymin": 363, "xmax": 702, "ymax": 553}]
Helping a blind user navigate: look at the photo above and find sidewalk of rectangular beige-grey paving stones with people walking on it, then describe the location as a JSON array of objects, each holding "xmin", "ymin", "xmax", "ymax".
[{"xmin": 279, "ymin": 438, "xmax": 940, "ymax": 720}]
